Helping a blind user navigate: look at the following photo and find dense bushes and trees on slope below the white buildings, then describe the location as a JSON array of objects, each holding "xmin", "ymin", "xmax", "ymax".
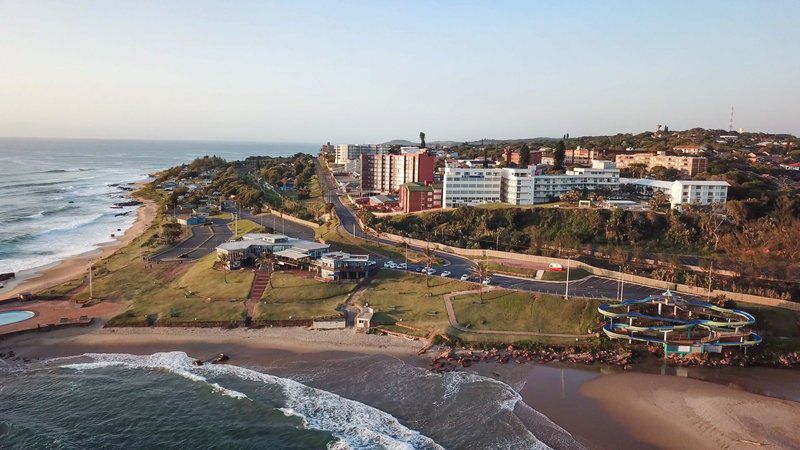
[{"xmin": 363, "ymin": 194, "xmax": 800, "ymax": 298}]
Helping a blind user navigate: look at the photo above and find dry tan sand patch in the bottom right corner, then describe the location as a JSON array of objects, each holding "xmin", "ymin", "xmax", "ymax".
[{"xmin": 580, "ymin": 373, "xmax": 800, "ymax": 449}]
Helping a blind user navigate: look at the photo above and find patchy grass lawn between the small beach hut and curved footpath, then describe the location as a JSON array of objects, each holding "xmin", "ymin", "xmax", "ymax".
[{"xmin": 361, "ymin": 270, "xmax": 475, "ymax": 332}]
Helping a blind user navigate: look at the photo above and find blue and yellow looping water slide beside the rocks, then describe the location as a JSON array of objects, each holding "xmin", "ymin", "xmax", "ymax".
[{"xmin": 597, "ymin": 291, "xmax": 761, "ymax": 357}]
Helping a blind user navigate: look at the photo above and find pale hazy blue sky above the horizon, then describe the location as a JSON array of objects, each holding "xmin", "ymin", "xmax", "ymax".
[{"xmin": 0, "ymin": 0, "xmax": 800, "ymax": 142}]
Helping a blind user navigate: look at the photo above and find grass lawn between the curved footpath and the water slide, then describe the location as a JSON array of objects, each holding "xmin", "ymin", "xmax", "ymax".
[{"xmin": 453, "ymin": 290, "xmax": 600, "ymax": 334}]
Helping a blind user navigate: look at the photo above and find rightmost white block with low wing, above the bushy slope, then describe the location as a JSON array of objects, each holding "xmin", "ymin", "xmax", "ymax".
[{"xmin": 620, "ymin": 178, "xmax": 730, "ymax": 209}]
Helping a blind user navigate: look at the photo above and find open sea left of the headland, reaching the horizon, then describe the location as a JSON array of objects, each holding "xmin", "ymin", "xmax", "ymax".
[{"xmin": 0, "ymin": 138, "xmax": 319, "ymax": 273}]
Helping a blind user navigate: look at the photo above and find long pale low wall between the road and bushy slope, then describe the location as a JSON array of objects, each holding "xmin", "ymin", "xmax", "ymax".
[{"xmin": 380, "ymin": 233, "xmax": 800, "ymax": 311}]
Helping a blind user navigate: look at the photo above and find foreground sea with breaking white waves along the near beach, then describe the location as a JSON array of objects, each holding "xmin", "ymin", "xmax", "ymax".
[{"xmin": 0, "ymin": 352, "xmax": 580, "ymax": 449}]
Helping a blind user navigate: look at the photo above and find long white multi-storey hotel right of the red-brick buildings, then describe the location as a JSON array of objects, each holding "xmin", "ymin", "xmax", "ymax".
[{"xmin": 442, "ymin": 160, "xmax": 619, "ymax": 208}]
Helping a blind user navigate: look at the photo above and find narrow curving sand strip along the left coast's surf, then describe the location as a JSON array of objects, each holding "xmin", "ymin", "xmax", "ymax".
[{"xmin": 0, "ymin": 186, "xmax": 158, "ymax": 303}]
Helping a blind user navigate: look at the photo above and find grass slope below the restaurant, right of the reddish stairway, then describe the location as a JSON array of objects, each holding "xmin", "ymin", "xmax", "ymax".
[{"xmin": 256, "ymin": 272, "xmax": 356, "ymax": 320}]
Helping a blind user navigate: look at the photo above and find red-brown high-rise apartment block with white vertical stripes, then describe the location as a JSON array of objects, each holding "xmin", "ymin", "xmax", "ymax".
[{"xmin": 361, "ymin": 149, "xmax": 435, "ymax": 192}]
